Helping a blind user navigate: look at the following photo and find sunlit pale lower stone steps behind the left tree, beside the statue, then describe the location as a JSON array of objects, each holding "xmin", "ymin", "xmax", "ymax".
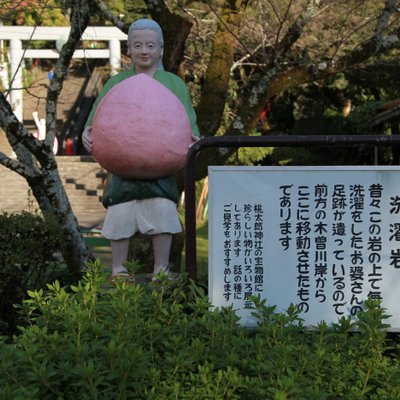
[{"xmin": 0, "ymin": 156, "xmax": 106, "ymax": 229}]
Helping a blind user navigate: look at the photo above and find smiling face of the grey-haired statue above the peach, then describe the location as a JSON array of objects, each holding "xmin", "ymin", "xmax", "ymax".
[{"xmin": 129, "ymin": 29, "xmax": 163, "ymax": 75}]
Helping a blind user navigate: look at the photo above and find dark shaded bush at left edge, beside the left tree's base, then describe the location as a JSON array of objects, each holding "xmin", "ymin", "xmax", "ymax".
[{"xmin": 0, "ymin": 212, "xmax": 70, "ymax": 334}]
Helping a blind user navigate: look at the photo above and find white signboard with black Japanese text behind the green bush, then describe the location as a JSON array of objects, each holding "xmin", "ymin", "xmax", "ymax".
[{"xmin": 209, "ymin": 166, "xmax": 400, "ymax": 331}]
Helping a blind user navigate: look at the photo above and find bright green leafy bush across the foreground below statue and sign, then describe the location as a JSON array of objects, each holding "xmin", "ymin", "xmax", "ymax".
[{"xmin": 0, "ymin": 263, "xmax": 400, "ymax": 400}]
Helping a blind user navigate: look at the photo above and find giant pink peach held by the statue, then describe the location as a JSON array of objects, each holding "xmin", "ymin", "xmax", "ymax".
[{"xmin": 92, "ymin": 74, "xmax": 192, "ymax": 179}]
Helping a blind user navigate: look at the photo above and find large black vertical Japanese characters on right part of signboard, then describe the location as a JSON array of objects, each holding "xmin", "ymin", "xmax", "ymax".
[{"xmin": 277, "ymin": 183, "xmax": 400, "ymax": 316}]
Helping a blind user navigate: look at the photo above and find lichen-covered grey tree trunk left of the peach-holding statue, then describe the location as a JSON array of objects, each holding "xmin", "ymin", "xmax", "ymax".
[{"xmin": 0, "ymin": 0, "xmax": 91, "ymax": 277}]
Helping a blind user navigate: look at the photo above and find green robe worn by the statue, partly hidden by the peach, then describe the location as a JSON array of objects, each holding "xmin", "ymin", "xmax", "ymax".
[{"xmin": 86, "ymin": 70, "xmax": 200, "ymax": 208}]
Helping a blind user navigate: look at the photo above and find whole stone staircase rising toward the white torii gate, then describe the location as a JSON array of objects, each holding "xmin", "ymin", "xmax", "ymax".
[{"xmin": 0, "ymin": 62, "xmax": 106, "ymax": 230}]
